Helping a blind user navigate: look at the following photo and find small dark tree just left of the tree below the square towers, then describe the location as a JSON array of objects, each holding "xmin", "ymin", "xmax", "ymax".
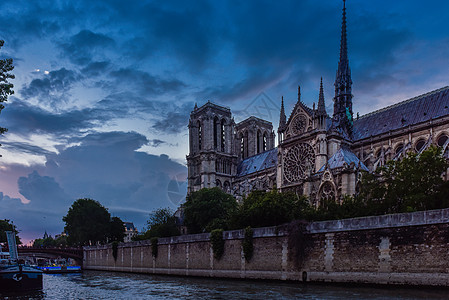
[{"xmin": 134, "ymin": 208, "xmax": 180, "ymax": 240}]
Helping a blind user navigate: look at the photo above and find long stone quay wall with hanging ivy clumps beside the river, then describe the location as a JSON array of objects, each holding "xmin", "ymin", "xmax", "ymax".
[{"xmin": 83, "ymin": 209, "xmax": 449, "ymax": 287}]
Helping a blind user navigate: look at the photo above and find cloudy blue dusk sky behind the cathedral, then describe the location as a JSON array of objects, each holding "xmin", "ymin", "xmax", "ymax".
[{"xmin": 0, "ymin": 0, "xmax": 449, "ymax": 243}]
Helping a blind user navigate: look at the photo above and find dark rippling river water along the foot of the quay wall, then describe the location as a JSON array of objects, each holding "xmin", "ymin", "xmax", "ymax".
[{"xmin": 0, "ymin": 271, "xmax": 449, "ymax": 300}]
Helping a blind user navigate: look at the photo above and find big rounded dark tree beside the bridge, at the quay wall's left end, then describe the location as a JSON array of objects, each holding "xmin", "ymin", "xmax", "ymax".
[{"xmin": 62, "ymin": 198, "xmax": 125, "ymax": 246}]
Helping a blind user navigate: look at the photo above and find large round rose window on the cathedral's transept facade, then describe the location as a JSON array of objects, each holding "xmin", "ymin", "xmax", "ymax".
[{"xmin": 284, "ymin": 143, "xmax": 315, "ymax": 182}]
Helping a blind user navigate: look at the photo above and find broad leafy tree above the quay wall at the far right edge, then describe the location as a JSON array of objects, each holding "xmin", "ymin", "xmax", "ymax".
[{"xmin": 358, "ymin": 146, "xmax": 449, "ymax": 214}]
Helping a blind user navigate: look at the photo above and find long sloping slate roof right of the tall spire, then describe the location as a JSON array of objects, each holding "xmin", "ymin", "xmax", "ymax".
[{"xmin": 354, "ymin": 86, "xmax": 449, "ymax": 141}]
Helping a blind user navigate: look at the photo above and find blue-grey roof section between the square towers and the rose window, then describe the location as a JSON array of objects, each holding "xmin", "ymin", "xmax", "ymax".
[{"xmin": 237, "ymin": 148, "xmax": 278, "ymax": 177}]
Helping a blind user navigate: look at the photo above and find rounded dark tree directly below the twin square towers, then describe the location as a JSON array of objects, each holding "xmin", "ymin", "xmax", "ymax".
[{"xmin": 184, "ymin": 187, "xmax": 237, "ymax": 233}]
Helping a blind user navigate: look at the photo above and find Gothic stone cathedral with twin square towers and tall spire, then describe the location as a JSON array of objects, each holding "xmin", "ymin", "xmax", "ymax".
[{"xmin": 187, "ymin": 0, "xmax": 449, "ymax": 206}]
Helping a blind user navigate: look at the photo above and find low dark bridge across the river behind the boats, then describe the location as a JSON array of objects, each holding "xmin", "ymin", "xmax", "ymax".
[{"xmin": 17, "ymin": 246, "xmax": 83, "ymax": 264}]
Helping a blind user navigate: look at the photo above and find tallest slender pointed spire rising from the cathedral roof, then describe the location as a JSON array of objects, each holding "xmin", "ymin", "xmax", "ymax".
[{"xmin": 332, "ymin": 0, "xmax": 353, "ymax": 138}]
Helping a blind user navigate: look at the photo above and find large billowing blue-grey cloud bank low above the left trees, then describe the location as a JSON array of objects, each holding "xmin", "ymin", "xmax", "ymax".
[{"xmin": 0, "ymin": 132, "xmax": 187, "ymax": 241}]
